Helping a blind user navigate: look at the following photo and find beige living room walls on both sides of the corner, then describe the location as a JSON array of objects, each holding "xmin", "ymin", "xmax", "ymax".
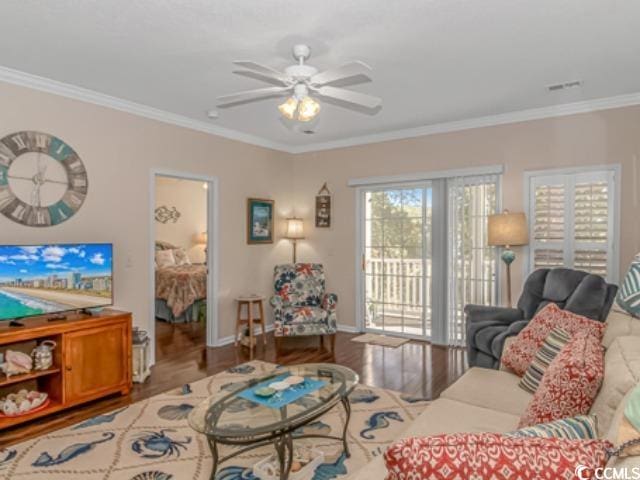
[{"xmin": 0, "ymin": 79, "xmax": 640, "ymax": 337}]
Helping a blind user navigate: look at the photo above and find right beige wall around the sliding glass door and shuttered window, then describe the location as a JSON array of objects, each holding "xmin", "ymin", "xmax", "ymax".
[{"xmin": 294, "ymin": 107, "xmax": 640, "ymax": 325}]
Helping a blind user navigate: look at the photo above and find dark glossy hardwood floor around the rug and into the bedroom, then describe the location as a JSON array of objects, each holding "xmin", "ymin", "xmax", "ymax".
[{"xmin": 0, "ymin": 322, "xmax": 466, "ymax": 447}]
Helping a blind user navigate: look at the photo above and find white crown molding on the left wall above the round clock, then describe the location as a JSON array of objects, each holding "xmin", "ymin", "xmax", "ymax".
[{"xmin": 0, "ymin": 66, "xmax": 290, "ymax": 153}]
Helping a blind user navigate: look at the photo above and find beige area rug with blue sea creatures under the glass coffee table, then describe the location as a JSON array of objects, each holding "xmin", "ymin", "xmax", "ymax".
[{"xmin": 0, "ymin": 361, "xmax": 428, "ymax": 480}]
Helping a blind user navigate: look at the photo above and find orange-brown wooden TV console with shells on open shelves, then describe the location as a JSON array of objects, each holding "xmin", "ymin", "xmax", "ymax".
[{"xmin": 0, "ymin": 310, "xmax": 132, "ymax": 430}]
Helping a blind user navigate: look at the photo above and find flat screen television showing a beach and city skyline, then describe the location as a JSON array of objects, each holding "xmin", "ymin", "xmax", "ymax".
[{"xmin": 0, "ymin": 243, "xmax": 113, "ymax": 321}]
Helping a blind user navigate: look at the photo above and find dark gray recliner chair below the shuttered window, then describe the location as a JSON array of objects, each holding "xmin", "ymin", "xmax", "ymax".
[{"xmin": 465, "ymin": 268, "xmax": 618, "ymax": 369}]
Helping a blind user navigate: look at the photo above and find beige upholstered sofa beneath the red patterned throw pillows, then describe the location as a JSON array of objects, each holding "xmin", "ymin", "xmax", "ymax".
[{"xmin": 349, "ymin": 307, "xmax": 640, "ymax": 480}]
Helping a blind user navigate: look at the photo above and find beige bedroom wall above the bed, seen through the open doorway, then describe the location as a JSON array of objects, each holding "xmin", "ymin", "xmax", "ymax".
[{"xmin": 155, "ymin": 177, "xmax": 207, "ymax": 263}]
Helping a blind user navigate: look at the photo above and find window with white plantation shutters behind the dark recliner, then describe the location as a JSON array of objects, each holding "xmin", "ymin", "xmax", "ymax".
[{"xmin": 525, "ymin": 168, "xmax": 617, "ymax": 281}]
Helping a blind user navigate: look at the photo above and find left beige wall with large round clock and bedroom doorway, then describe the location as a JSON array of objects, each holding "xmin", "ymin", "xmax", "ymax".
[{"xmin": 0, "ymin": 83, "xmax": 292, "ymax": 337}]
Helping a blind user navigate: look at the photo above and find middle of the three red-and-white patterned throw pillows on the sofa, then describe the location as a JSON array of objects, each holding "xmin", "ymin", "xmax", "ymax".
[{"xmin": 518, "ymin": 332, "xmax": 604, "ymax": 428}]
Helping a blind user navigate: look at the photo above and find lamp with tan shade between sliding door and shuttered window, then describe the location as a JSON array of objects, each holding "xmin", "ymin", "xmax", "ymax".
[{"xmin": 488, "ymin": 210, "xmax": 529, "ymax": 307}]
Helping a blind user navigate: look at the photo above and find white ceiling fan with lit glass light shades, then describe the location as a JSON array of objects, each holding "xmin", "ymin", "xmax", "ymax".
[{"xmin": 217, "ymin": 44, "xmax": 382, "ymax": 122}]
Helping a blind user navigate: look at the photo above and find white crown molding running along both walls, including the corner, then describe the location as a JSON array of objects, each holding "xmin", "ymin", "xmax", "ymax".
[{"xmin": 0, "ymin": 66, "xmax": 640, "ymax": 154}]
